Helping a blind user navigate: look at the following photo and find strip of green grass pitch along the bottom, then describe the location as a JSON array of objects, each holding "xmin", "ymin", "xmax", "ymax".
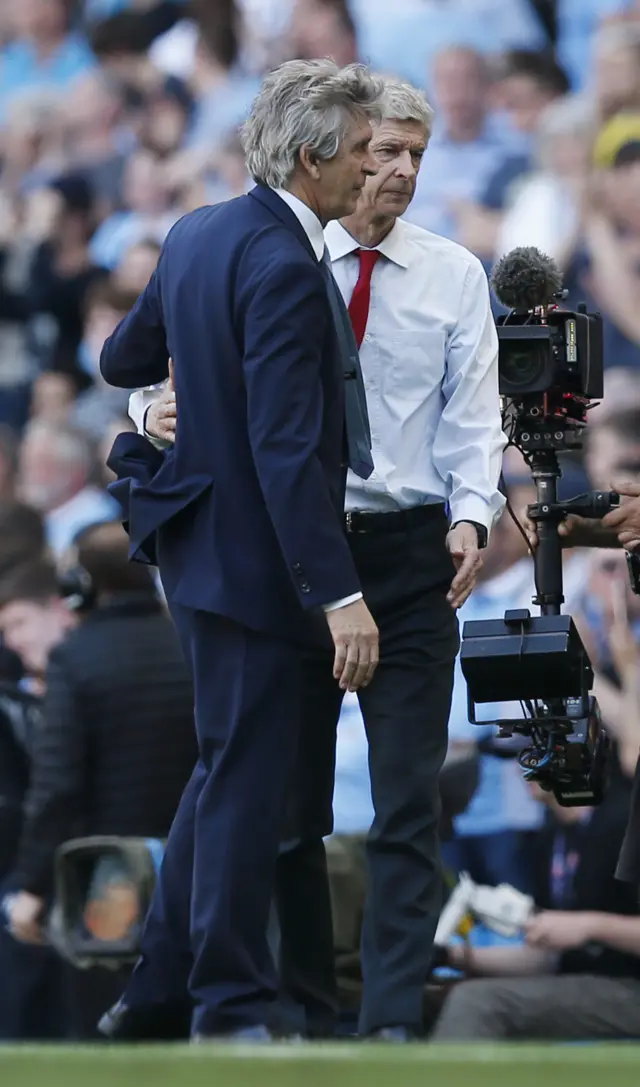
[{"xmin": 0, "ymin": 1042, "xmax": 640, "ymax": 1087}]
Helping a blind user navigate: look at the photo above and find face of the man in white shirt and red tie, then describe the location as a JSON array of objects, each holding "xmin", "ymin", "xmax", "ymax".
[{"xmin": 367, "ymin": 121, "xmax": 427, "ymax": 215}]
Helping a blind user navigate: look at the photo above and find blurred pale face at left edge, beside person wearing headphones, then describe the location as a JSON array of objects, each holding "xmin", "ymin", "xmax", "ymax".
[{"xmin": 0, "ymin": 599, "xmax": 74, "ymax": 675}]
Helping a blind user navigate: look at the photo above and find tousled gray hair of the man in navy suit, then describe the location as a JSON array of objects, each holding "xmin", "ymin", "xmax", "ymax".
[{"xmin": 241, "ymin": 60, "xmax": 384, "ymax": 188}]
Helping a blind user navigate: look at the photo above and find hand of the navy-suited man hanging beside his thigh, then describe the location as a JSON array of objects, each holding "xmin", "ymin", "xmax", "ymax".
[{"xmin": 326, "ymin": 600, "xmax": 379, "ymax": 691}]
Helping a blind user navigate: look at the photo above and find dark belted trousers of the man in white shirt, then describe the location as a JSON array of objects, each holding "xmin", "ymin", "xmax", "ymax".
[{"xmin": 277, "ymin": 507, "xmax": 459, "ymax": 1035}]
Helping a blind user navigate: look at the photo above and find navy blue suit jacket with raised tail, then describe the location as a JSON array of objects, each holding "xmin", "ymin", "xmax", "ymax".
[{"xmin": 100, "ymin": 186, "xmax": 360, "ymax": 636}]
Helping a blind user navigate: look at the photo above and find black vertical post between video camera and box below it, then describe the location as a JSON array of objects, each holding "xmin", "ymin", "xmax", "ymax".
[{"xmin": 531, "ymin": 450, "xmax": 564, "ymax": 615}]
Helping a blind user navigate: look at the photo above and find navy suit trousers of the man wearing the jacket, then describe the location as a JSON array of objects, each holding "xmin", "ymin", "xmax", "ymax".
[{"xmin": 126, "ymin": 607, "xmax": 300, "ymax": 1035}]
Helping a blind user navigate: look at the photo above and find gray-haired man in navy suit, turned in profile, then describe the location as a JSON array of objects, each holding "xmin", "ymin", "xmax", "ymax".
[{"xmin": 101, "ymin": 61, "xmax": 382, "ymax": 1039}]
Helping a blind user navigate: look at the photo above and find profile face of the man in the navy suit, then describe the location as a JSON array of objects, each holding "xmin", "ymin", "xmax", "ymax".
[{"xmin": 311, "ymin": 116, "xmax": 378, "ymax": 223}]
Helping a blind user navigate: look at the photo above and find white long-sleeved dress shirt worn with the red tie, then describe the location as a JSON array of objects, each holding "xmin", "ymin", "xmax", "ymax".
[{"xmin": 325, "ymin": 218, "xmax": 506, "ymax": 532}]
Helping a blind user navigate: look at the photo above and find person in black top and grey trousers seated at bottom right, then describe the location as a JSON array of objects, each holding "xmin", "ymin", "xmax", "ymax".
[{"xmin": 431, "ymin": 786, "xmax": 640, "ymax": 1042}]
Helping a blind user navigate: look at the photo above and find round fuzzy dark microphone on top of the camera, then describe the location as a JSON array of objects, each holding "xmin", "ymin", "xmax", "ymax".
[{"xmin": 491, "ymin": 246, "xmax": 562, "ymax": 313}]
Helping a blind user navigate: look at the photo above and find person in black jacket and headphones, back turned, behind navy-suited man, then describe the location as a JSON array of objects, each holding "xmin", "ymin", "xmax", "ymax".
[{"xmin": 0, "ymin": 524, "xmax": 197, "ymax": 1037}]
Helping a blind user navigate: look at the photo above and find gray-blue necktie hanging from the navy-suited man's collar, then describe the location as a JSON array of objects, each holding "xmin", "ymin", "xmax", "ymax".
[{"xmin": 321, "ymin": 247, "xmax": 374, "ymax": 479}]
